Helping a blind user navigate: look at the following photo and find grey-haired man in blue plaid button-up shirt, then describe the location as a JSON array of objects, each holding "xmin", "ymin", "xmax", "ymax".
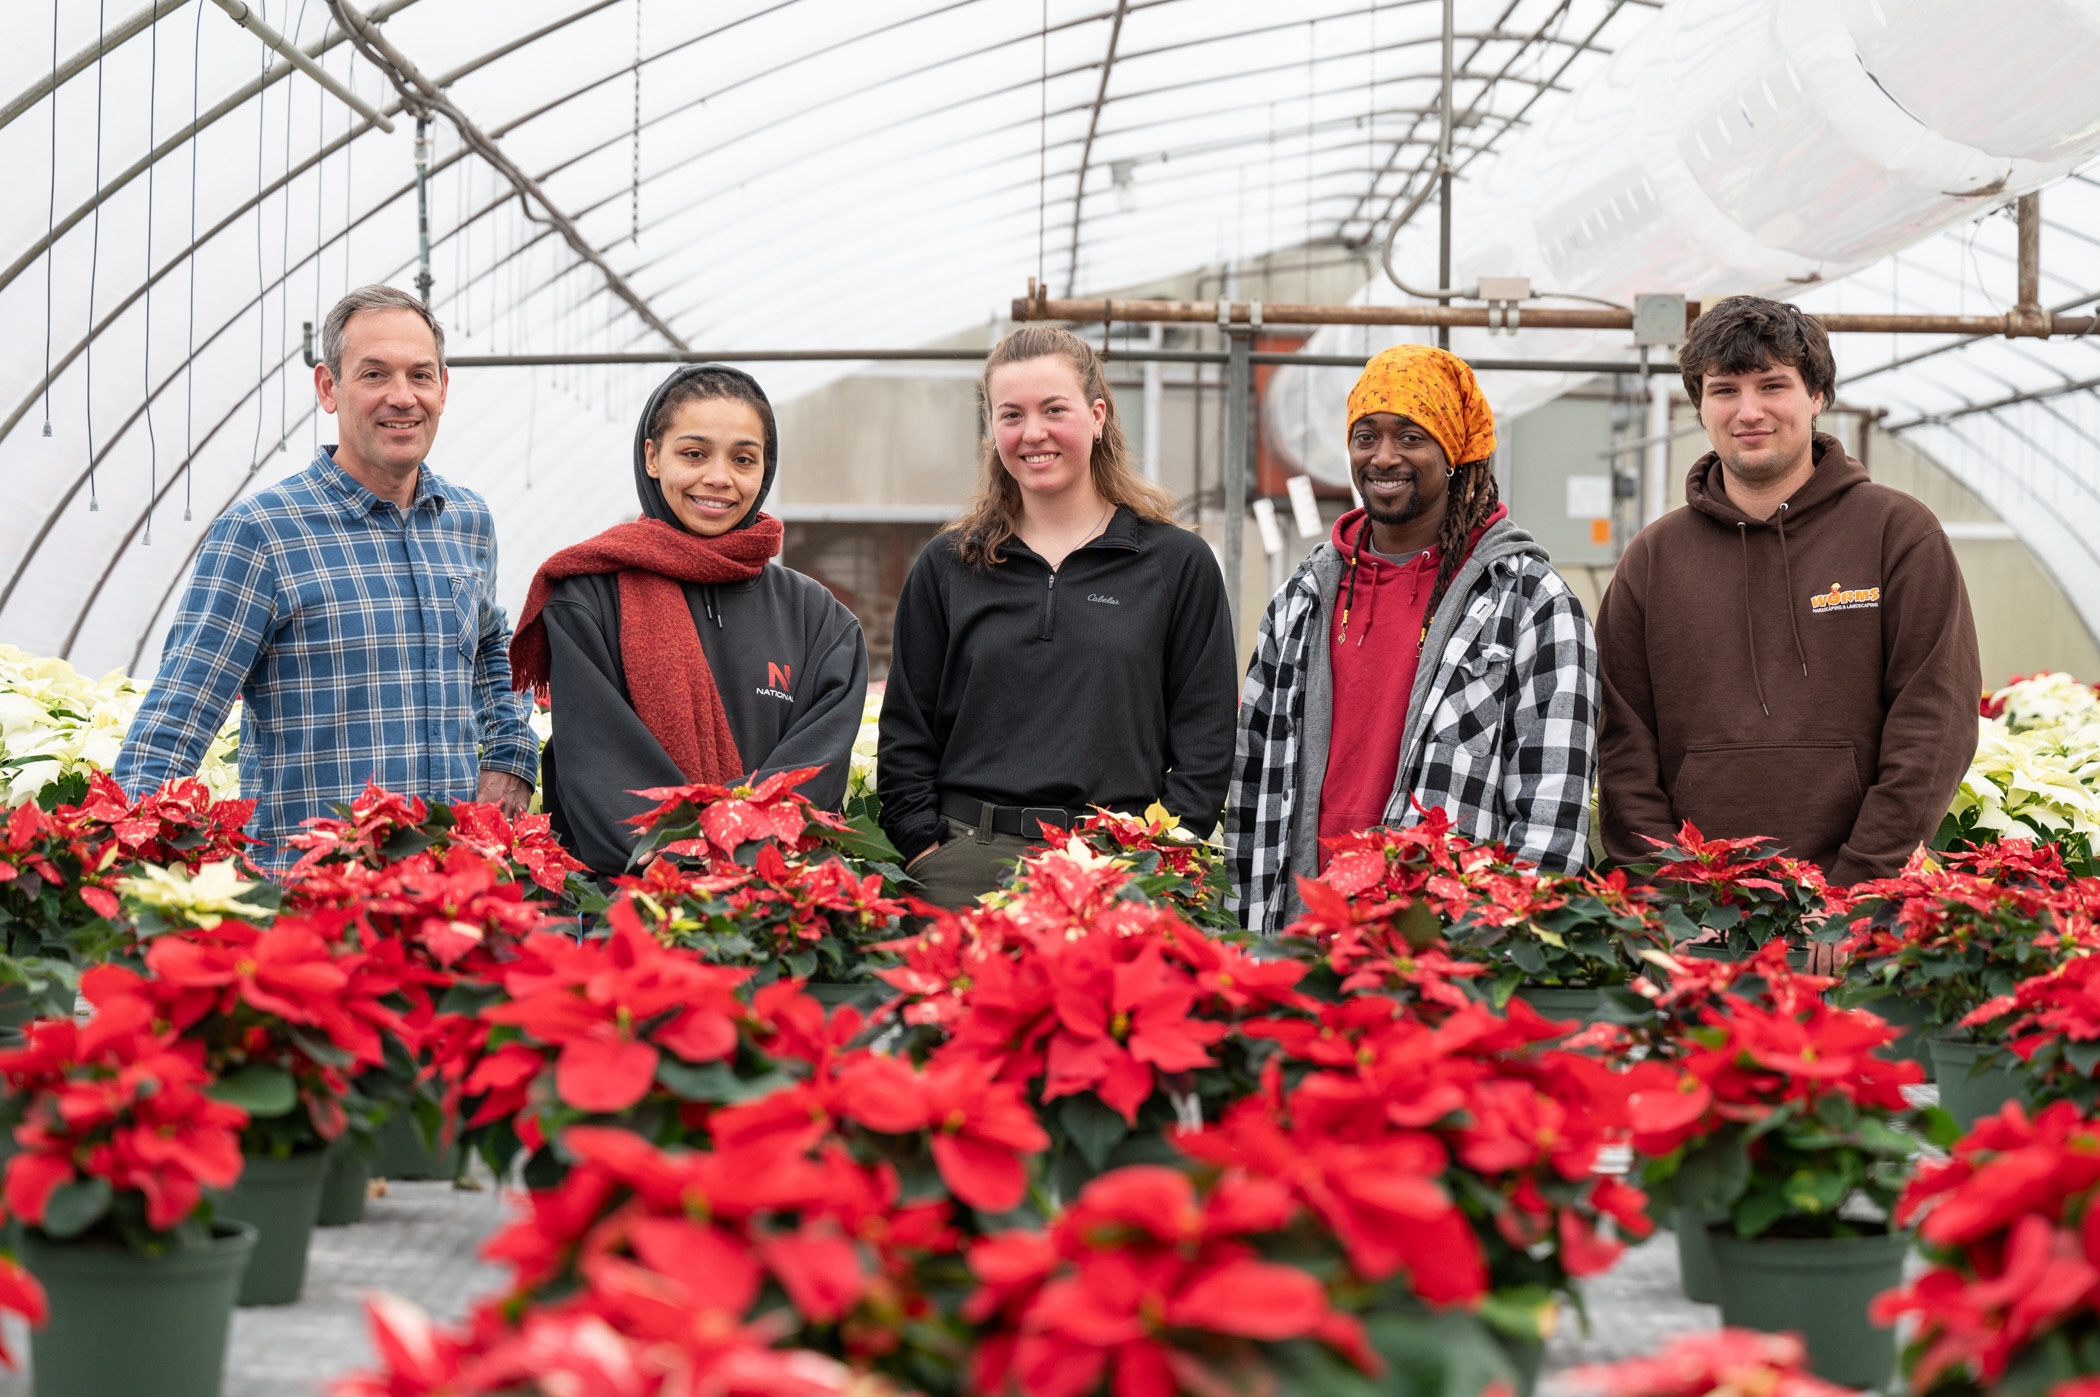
[{"xmin": 116, "ymin": 286, "xmax": 540, "ymax": 868}]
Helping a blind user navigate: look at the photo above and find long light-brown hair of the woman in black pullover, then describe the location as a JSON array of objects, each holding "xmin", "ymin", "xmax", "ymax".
[{"xmin": 947, "ymin": 326, "xmax": 1174, "ymax": 569}]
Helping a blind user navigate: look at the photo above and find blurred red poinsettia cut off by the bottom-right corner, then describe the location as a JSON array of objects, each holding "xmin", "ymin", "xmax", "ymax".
[{"xmin": 1873, "ymin": 1101, "xmax": 2100, "ymax": 1397}]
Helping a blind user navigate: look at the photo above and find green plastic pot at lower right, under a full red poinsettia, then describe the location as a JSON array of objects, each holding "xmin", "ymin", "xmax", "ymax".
[{"xmin": 1707, "ymin": 1227, "xmax": 1911, "ymax": 1389}]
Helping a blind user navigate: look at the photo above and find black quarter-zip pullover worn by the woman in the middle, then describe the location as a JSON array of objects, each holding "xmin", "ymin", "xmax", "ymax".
[{"xmin": 876, "ymin": 508, "xmax": 1237, "ymax": 859}]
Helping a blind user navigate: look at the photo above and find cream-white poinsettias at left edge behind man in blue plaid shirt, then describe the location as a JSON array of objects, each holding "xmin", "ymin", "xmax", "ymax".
[{"xmin": 0, "ymin": 645, "xmax": 242, "ymax": 805}]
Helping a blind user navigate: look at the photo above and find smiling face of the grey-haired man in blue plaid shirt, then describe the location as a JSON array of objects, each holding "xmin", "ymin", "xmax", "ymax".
[{"xmin": 313, "ymin": 309, "xmax": 445, "ymax": 479}]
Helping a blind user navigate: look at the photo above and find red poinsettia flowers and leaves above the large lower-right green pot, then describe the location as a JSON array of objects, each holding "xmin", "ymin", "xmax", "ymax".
[{"xmin": 1628, "ymin": 941, "xmax": 1955, "ymax": 1237}]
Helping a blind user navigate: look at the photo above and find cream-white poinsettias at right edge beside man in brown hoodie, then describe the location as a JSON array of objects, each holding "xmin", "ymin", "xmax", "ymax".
[{"xmin": 1936, "ymin": 674, "xmax": 2100, "ymax": 866}]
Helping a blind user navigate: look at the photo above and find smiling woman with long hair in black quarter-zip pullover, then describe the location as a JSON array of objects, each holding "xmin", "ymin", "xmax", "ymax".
[{"xmin": 876, "ymin": 326, "xmax": 1237, "ymax": 908}]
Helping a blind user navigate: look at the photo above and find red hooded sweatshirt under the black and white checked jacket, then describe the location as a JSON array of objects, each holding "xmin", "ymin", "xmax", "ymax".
[{"xmin": 1319, "ymin": 495, "xmax": 1508, "ymax": 868}]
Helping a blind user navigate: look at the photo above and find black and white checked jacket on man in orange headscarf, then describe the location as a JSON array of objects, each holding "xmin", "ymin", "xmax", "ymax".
[{"xmin": 1224, "ymin": 519, "xmax": 1600, "ymax": 935}]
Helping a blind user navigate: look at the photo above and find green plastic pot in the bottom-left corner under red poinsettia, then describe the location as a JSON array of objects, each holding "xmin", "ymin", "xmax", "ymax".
[{"xmin": 21, "ymin": 1223, "xmax": 256, "ymax": 1397}]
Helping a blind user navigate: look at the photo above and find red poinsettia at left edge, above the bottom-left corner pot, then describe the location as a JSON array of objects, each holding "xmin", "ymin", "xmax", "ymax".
[{"xmin": 0, "ymin": 966, "xmax": 248, "ymax": 1256}]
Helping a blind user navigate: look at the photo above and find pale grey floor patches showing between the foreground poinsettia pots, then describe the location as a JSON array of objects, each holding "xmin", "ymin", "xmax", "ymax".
[{"xmin": 0, "ymin": 1183, "xmax": 1718, "ymax": 1397}]
